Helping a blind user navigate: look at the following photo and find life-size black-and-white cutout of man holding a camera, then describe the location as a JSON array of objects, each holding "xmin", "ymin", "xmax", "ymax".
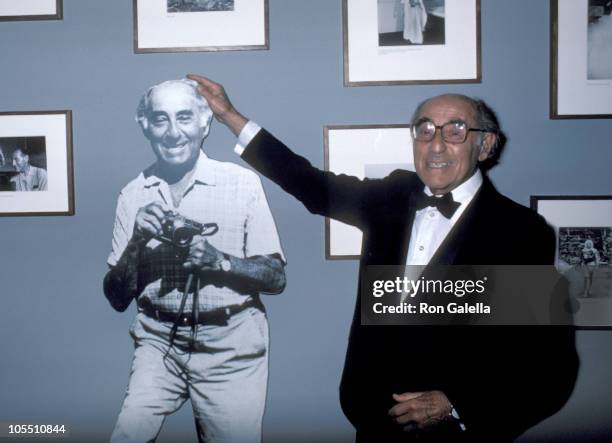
[{"xmin": 104, "ymin": 80, "xmax": 285, "ymax": 443}]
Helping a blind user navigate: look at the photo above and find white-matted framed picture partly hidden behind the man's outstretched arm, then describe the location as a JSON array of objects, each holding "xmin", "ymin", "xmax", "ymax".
[{"xmin": 323, "ymin": 124, "xmax": 414, "ymax": 260}]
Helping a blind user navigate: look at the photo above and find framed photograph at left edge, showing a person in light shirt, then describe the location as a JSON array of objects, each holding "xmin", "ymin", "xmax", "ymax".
[{"xmin": 0, "ymin": 111, "xmax": 74, "ymax": 216}]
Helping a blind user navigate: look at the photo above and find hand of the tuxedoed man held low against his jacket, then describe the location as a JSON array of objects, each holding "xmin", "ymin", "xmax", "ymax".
[{"xmin": 389, "ymin": 391, "xmax": 452, "ymax": 432}]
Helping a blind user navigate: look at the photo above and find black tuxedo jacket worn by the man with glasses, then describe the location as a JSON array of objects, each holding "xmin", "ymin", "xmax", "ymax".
[{"xmin": 242, "ymin": 130, "xmax": 578, "ymax": 442}]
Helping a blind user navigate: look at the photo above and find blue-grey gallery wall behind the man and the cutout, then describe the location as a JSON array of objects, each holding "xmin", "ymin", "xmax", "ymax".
[{"xmin": 0, "ymin": 0, "xmax": 612, "ymax": 442}]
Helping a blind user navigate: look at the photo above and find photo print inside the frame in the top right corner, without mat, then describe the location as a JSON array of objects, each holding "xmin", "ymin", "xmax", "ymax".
[{"xmin": 587, "ymin": 0, "xmax": 612, "ymax": 80}]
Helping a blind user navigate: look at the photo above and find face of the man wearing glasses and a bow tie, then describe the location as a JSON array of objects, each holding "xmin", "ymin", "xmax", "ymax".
[{"xmin": 414, "ymin": 96, "xmax": 492, "ymax": 195}]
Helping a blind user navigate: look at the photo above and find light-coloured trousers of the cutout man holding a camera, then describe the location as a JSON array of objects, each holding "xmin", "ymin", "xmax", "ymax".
[{"xmin": 111, "ymin": 308, "xmax": 269, "ymax": 443}]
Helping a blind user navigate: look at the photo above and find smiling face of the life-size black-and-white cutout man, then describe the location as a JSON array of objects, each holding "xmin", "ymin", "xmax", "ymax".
[{"xmin": 144, "ymin": 84, "xmax": 206, "ymax": 166}]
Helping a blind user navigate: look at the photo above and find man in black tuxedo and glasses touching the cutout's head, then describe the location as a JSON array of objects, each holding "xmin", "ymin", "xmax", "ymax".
[{"xmin": 189, "ymin": 75, "xmax": 578, "ymax": 443}]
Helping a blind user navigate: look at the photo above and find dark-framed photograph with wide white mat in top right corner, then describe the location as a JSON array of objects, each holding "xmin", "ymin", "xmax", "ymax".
[{"xmin": 550, "ymin": 0, "xmax": 612, "ymax": 119}]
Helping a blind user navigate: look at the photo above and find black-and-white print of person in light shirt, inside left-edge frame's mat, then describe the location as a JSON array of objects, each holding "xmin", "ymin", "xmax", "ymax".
[{"xmin": 0, "ymin": 137, "xmax": 47, "ymax": 192}]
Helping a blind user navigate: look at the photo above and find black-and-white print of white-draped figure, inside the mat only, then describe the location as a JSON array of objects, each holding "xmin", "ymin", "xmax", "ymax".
[{"xmin": 378, "ymin": 0, "xmax": 446, "ymax": 46}]
